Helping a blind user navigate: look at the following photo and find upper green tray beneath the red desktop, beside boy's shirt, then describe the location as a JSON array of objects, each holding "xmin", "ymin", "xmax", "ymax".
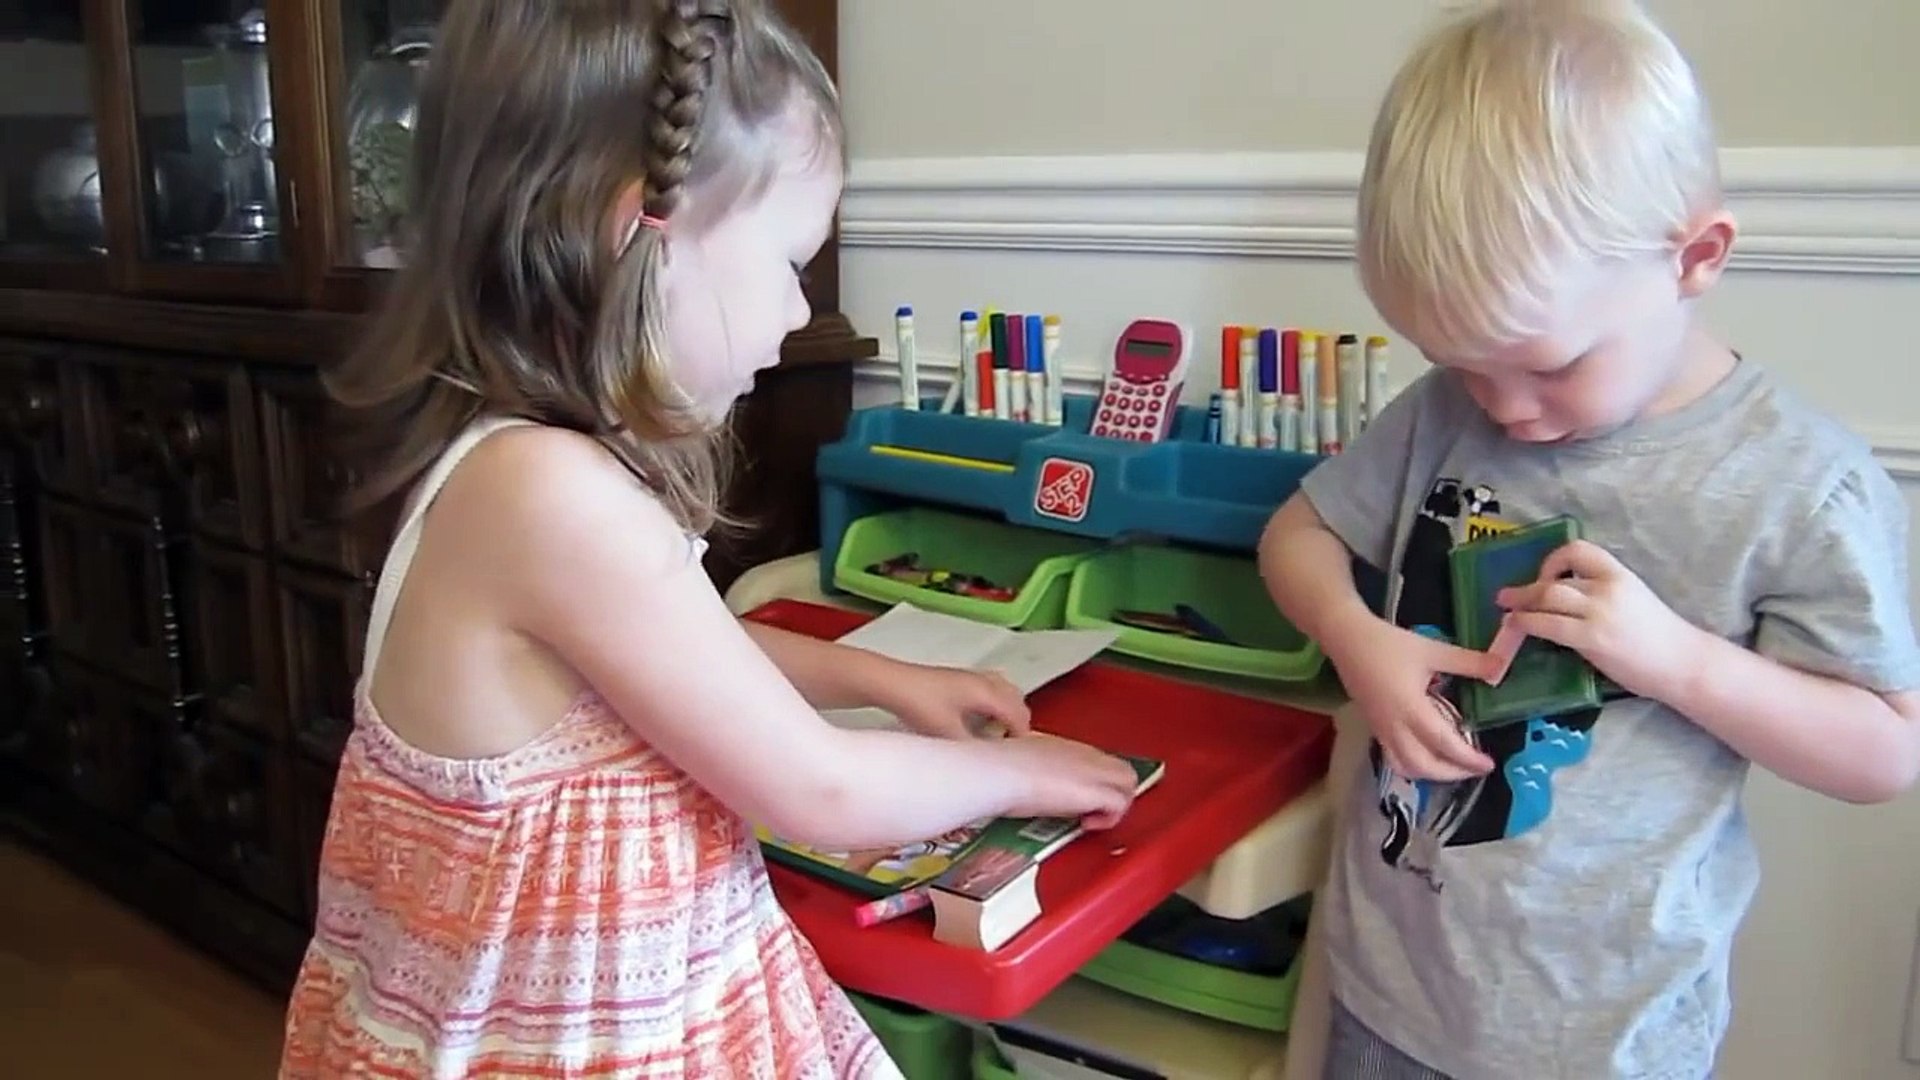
[{"xmin": 1079, "ymin": 940, "xmax": 1306, "ymax": 1032}]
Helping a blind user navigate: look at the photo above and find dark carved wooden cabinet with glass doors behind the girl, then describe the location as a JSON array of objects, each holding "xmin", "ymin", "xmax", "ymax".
[{"xmin": 0, "ymin": 0, "xmax": 876, "ymax": 988}]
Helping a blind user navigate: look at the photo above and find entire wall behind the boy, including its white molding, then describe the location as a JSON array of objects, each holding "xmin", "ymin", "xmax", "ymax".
[{"xmin": 841, "ymin": 0, "xmax": 1920, "ymax": 1080}]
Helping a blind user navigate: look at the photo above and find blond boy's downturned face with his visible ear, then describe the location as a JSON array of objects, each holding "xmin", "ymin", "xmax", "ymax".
[{"xmin": 1400, "ymin": 215, "xmax": 1732, "ymax": 444}]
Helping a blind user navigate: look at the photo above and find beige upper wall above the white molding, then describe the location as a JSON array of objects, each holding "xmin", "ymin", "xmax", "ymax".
[{"xmin": 839, "ymin": 0, "xmax": 1920, "ymax": 158}]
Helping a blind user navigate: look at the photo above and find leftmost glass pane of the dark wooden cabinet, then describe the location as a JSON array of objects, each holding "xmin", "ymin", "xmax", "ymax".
[{"xmin": 0, "ymin": 0, "xmax": 108, "ymax": 265}]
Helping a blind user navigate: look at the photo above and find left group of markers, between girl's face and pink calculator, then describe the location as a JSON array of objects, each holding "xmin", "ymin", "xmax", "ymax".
[{"xmin": 893, "ymin": 307, "xmax": 1066, "ymax": 427}]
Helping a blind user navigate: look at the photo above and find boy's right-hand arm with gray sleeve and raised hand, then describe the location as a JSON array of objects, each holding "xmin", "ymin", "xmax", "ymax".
[{"xmin": 1501, "ymin": 463, "xmax": 1920, "ymax": 803}]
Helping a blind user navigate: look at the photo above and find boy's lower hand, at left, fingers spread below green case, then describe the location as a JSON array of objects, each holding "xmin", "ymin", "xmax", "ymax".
[{"xmin": 1321, "ymin": 611, "xmax": 1496, "ymax": 780}]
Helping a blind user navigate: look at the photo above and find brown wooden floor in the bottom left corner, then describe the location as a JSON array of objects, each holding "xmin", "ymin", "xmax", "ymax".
[{"xmin": 0, "ymin": 838, "xmax": 282, "ymax": 1080}]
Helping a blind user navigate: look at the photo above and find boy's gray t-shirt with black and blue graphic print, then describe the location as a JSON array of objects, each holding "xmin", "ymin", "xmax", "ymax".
[{"xmin": 1304, "ymin": 361, "xmax": 1920, "ymax": 1080}]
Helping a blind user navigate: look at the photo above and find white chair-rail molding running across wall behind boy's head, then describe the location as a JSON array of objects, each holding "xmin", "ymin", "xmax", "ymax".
[{"xmin": 841, "ymin": 146, "xmax": 1920, "ymax": 273}]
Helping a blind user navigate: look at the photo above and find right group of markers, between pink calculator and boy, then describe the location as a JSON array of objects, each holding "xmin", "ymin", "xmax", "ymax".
[{"xmin": 1208, "ymin": 327, "xmax": 1388, "ymax": 454}]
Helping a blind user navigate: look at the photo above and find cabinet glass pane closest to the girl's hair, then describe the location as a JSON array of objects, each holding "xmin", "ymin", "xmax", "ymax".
[{"xmin": 323, "ymin": 0, "xmax": 445, "ymax": 269}]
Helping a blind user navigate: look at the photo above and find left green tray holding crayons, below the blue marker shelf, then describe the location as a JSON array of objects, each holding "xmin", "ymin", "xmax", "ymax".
[{"xmin": 833, "ymin": 507, "xmax": 1098, "ymax": 630}]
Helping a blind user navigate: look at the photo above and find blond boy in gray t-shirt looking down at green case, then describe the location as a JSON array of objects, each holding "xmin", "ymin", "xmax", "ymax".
[{"xmin": 1261, "ymin": 0, "xmax": 1920, "ymax": 1080}]
